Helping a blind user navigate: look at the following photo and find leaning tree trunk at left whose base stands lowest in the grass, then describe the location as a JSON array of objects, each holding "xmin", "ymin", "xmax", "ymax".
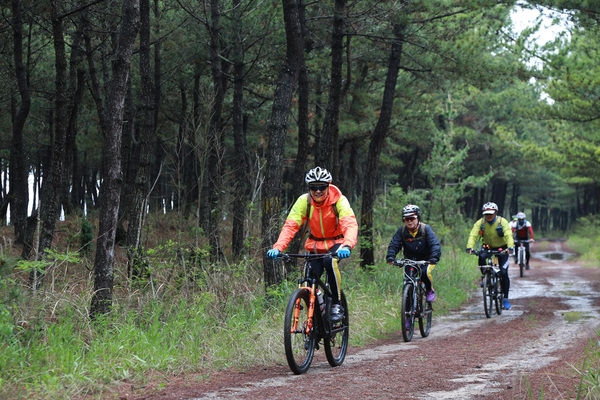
[{"xmin": 90, "ymin": 0, "xmax": 140, "ymax": 319}]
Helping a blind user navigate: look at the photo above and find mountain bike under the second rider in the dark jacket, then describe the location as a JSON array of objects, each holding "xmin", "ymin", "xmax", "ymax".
[{"xmin": 392, "ymin": 259, "xmax": 433, "ymax": 342}]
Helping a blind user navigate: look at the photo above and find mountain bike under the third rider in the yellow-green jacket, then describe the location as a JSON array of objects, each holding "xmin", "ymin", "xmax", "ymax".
[{"xmin": 472, "ymin": 248, "xmax": 507, "ymax": 318}]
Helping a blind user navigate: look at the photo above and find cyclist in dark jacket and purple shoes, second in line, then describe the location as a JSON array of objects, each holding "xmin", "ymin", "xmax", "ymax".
[{"xmin": 385, "ymin": 204, "xmax": 442, "ymax": 301}]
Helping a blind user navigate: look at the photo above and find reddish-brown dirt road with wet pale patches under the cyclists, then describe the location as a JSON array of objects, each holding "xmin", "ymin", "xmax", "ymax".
[{"xmin": 120, "ymin": 242, "xmax": 600, "ymax": 400}]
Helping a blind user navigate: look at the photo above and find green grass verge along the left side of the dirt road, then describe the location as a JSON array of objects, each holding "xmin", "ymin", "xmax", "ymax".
[{"xmin": 0, "ymin": 245, "xmax": 479, "ymax": 399}]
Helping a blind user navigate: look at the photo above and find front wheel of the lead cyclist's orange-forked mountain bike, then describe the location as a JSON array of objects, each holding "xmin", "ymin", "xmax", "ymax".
[{"xmin": 283, "ymin": 289, "xmax": 317, "ymax": 375}]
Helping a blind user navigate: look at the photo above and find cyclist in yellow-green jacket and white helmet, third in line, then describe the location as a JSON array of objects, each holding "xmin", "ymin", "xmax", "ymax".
[{"xmin": 467, "ymin": 202, "xmax": 515, "ymax": 310}]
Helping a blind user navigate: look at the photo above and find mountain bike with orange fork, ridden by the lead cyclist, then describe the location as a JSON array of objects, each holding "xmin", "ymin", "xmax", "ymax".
[{"xmin": 280, "ymin": 253, "xmax": 349, "ymax": 375}]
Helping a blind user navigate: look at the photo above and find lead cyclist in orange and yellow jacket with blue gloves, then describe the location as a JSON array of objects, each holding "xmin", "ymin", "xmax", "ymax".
[{"xmin": 267, "ymin": 167, "xmax": 358, "ymax": 323}]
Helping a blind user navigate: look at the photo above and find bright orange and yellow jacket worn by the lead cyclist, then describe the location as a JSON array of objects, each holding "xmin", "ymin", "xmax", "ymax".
[{"xmin": 273, "ymin": 185, "xmax": 358, "ymax": 253}]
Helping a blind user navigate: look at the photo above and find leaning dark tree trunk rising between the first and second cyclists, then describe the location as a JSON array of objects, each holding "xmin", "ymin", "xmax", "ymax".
[{"xmin": 360, "ymin": 23, "xmax": 405, "ymax": 267}]
